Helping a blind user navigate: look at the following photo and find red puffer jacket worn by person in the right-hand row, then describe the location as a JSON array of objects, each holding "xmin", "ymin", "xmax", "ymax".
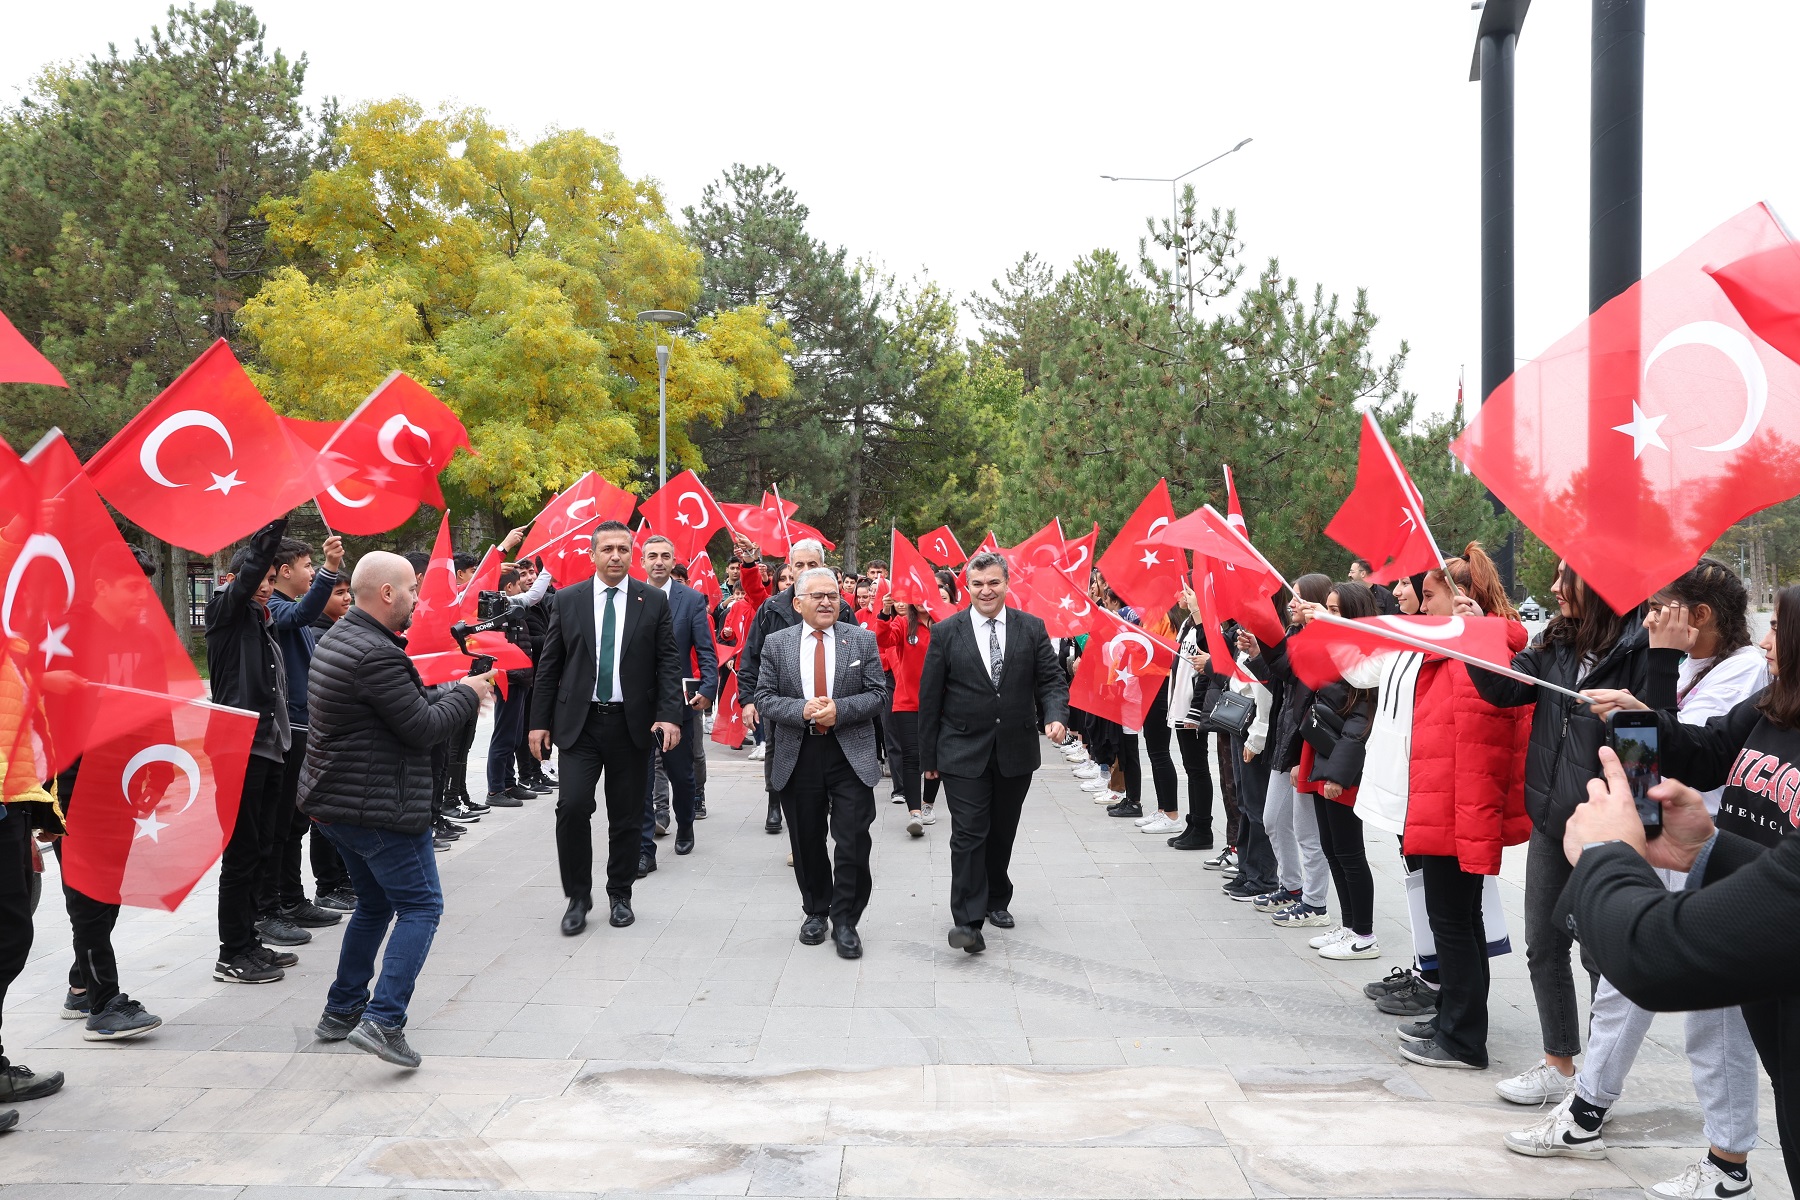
[{"xmin": 1404, "ymin": 621, "xmax": 1532, "ymax": 874}]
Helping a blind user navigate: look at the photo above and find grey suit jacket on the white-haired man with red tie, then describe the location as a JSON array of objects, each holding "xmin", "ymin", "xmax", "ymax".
[{"xmin": 756, "ymin": 621, "xmax": 887, "ymax": 790}]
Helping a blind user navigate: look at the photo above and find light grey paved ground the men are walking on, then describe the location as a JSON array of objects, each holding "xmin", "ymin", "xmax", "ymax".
[{"xmin": 0, "ymin": 719, "xmax": 1787, "ymax": 1200}]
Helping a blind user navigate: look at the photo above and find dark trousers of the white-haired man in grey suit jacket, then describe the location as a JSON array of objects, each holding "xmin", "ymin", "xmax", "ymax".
[{"xmin": 778, "ymin": 734, "xmax": 875, "ymax": 928}]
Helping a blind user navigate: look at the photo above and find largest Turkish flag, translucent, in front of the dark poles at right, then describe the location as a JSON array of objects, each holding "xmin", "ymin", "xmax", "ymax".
[{"xmin": 1451, "ymin": 205, "xmax": 1800, "ymax": 612}]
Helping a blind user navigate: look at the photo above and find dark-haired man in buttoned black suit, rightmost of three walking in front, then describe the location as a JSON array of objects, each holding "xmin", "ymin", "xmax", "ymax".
[{"xmin": 918, "ymin": 552, "xmax": 1069, "ymax": 954}]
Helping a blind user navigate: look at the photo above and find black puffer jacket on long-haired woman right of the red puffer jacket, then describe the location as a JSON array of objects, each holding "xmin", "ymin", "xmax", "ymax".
[{"xmin": 1469, "ymin": 628, "xmax": 1651, "ymax": 840}]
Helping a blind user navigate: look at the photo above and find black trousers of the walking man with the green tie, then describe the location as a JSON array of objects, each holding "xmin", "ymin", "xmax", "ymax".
[{"xmin": 556, "ymin": 703, "xmax": 650, "ymax": 901}]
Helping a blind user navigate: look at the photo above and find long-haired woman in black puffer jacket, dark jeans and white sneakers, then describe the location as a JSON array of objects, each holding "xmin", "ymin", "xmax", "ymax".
[{"xmin": 1456, "ymin": 561, "xmax": 1651, "ymax": 1105}]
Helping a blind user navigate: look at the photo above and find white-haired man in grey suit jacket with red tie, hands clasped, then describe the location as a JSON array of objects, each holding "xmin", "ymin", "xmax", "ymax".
[{"xmin": 756, "ymin": 567, "xmax": 887, "ymax": 959}]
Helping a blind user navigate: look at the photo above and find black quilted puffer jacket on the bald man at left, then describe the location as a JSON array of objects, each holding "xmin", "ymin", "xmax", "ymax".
[{"xmin": 299, "ymin": 608, "xmax": 481, "ymax": 833}]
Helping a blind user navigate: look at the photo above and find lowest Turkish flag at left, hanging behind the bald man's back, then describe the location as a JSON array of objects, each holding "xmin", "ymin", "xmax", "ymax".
[{"xmin": 63, "ymin": 684, "xmax": 257, "ymax": 912}]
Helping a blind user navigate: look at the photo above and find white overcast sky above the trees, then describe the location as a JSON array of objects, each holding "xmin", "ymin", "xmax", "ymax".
[{"xmin": 0, "ymin": 0, "xmax": 1800, "ymax": 417}]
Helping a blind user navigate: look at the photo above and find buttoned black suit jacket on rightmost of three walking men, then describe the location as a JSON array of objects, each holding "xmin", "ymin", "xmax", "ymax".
[{"xmin": 918, "ymin": 608, "xmax": 1069, "ymax": 777}]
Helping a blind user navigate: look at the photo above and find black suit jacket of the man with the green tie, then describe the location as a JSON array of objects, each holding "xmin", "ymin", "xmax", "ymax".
[{"xmin": 531, "ymin": 578, "xmax": 688, "ymax": 750}]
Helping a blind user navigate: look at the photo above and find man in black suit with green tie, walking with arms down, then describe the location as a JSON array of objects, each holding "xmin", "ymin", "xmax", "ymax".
[{"xmin": 531, "ymin": 520, "xmax": 682, "ymax": 936}]
